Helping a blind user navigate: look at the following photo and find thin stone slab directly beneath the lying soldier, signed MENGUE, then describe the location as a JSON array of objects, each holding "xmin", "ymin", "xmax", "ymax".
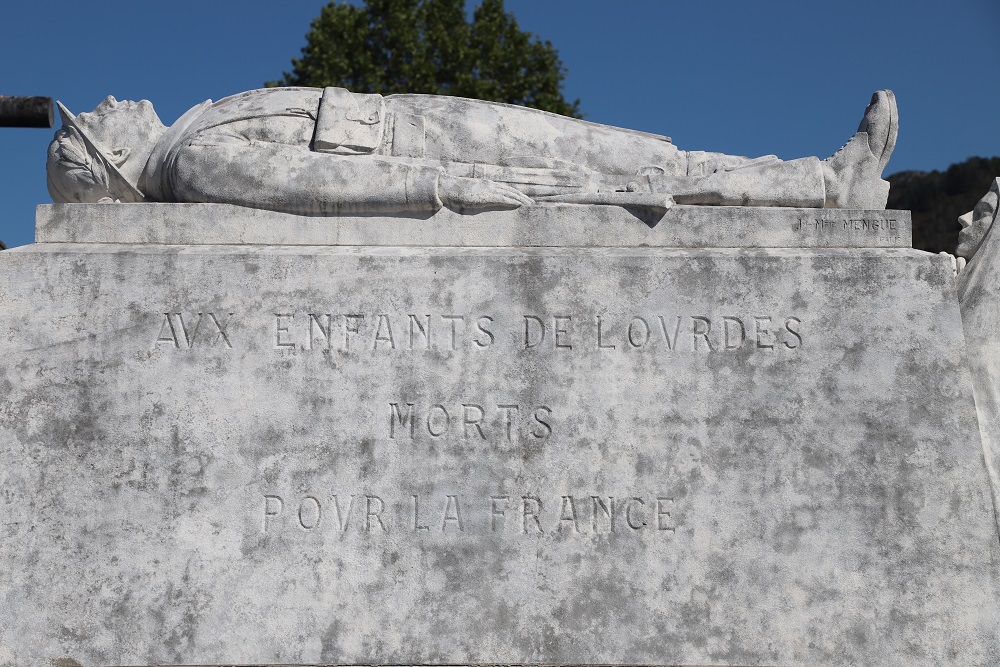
[{"xmin": 35, "ymin": 204, "xmax": 913, "ymax": 248}]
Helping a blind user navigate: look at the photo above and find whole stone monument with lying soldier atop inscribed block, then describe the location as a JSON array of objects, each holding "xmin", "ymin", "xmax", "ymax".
[{"xmin": 0, "ymin": 89, "xmax": 1000, "ymax": 667}]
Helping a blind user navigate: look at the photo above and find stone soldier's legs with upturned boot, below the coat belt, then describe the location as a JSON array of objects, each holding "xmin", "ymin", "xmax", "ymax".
[{"xmin": 386, "ymin": 91, "xmax": 898, "ymax": 208}]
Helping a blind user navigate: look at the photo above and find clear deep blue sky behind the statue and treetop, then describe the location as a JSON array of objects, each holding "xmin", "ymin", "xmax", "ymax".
[{"xmin": 0, "ymin": 0, "xmax": 1000, "ymax": 246}]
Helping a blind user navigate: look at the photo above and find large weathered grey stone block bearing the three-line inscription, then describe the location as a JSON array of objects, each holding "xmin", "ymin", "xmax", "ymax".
[{"xmin": 0, "ymin": 207, "xmax": 1000, "ymax": 666}]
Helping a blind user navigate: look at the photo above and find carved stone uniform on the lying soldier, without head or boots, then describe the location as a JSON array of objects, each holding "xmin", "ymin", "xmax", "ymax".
[{"xmin": 140, "ymin": 88, "xmax": 823, "ymax": 214}]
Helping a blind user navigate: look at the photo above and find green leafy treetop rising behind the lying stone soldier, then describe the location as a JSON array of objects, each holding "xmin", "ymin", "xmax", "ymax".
[{"xmin": 267, "ymin": 0, "xmax": 580, "ymax": 117}]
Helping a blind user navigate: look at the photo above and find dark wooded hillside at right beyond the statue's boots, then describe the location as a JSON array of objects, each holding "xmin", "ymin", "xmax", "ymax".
[{"xmin": 886, "ymin": 157, "xmax": 1000, "ymax": 253}]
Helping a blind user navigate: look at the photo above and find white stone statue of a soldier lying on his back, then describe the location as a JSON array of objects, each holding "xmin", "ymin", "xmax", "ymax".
[{"xmin": 48, "ymin": 88, "xmax": 898, "ymax": 215}]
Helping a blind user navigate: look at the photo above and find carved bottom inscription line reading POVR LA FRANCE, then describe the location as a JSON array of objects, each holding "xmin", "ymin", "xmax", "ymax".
[{"xmin": 260, "ymin": 492, "xmax": 676, "ymax": 536}]
